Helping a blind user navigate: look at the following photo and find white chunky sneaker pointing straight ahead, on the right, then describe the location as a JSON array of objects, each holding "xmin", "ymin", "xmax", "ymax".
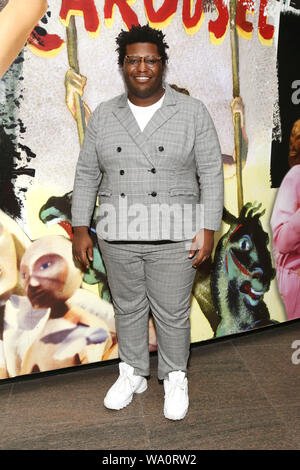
[{"xmin": 164, "ymin": 370, "xmax": 189, "ymax": 420}]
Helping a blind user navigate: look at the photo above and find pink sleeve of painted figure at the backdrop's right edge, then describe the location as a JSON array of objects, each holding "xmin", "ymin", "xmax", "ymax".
[{"xmin": 271, "ymin": 165, "xmax": 300, "ymax": 254}]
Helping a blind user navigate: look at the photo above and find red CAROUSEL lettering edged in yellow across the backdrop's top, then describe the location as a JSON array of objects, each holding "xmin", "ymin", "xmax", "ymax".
[{"xmin": 28, "ymin": 0, "xmax": 274, "ymax": 57}]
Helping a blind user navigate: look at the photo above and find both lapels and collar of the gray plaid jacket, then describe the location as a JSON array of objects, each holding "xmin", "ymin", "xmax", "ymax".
[{"xmin": 113, "ymin": 84, "xmax": 178, "ymax": 166}]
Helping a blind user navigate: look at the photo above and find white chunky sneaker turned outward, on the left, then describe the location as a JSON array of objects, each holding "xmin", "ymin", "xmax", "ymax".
[{"xmin": 104, "ymin": 362, "xmax": 147, "ymax": 410}]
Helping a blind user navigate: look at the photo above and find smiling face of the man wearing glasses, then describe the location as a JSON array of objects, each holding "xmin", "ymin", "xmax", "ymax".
[{"xmin": 122, "ymin": 42, "xmax": 164, "ymax": 106}]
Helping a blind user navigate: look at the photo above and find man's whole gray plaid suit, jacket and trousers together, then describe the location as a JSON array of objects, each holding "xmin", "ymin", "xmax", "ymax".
[{"xmin": 72, "ymin": 84, "xmax": 223, "ymax": 379}]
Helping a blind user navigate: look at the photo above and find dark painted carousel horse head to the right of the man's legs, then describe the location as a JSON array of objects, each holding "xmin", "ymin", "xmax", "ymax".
[{"xmin": 211, "ymin": 203, "xmax": 275, "ymax": 336}]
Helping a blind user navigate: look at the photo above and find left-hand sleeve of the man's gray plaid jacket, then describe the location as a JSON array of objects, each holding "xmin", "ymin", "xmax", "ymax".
[{"xmin": 72, "ymin": 108, "xmax": 102, "ymax": 227}]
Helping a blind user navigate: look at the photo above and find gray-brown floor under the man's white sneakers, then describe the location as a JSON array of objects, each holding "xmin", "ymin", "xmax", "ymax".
[{"xmin": 0, "ymin": 320, "xmax": 300, "ymax": 450}]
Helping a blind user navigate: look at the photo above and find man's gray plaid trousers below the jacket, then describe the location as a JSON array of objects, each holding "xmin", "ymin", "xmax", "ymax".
[{"xmin": 98, "ymin": 239, "xmax": 195, "ymax": 380}]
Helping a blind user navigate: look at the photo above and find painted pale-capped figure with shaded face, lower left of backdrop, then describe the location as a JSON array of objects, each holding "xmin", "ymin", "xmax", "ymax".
[{"xmin": 20, "ymin": 235, "xmax": 112, "ymax": 374}]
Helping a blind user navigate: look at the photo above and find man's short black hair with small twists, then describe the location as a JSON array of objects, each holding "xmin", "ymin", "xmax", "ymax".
[{"xmin": 116, "ymin": 24, "xmax": 169, "ymax": 66}]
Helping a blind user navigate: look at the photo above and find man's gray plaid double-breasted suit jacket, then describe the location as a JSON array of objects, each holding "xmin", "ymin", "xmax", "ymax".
[{"xmin": 72, "ymin": 84, "xmax": 224, "ymax": 241}]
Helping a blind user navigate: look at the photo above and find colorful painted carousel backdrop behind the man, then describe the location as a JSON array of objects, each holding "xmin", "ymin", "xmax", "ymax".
[{"xmin": 0, "ymin": 0, "xmax": 300, "ymax": 378}]
